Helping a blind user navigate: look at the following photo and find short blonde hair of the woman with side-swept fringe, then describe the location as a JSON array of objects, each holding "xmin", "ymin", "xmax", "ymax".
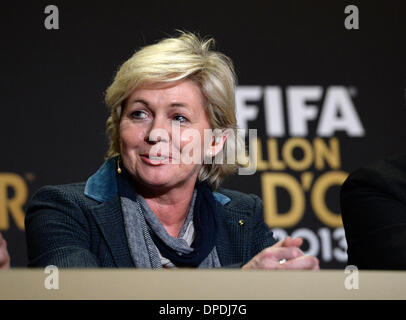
[{"xmin": 105, "ymin": 31, "xmax": 243, "ymax": 189}]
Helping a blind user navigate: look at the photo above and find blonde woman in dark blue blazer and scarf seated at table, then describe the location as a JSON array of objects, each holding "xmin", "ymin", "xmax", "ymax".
[{"xmin": 26, "ymin": 32, "xmax": 319, "ymax": 269}]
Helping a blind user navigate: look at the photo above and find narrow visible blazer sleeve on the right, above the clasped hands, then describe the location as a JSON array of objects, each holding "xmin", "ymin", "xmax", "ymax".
[{"xmin": 250, "ymin": 194, "xmax": 276, "ymax": 258}]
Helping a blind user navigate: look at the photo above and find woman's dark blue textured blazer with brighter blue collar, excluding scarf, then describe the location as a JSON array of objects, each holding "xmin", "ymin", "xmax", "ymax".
[{"xmin": 25, "ymin": 159, "xmax": 275, "ymax": 268}]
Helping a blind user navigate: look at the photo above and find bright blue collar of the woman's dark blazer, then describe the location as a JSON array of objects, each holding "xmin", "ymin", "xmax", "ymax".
[{"xmin": 84, "ymin": 158, "xmax": 231, "ymax": 206}]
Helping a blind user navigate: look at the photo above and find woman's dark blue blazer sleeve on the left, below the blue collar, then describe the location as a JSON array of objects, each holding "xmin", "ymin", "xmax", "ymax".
[{"xmin": 25, "ymin": 186, "xmax": 100, "ymax": 268}]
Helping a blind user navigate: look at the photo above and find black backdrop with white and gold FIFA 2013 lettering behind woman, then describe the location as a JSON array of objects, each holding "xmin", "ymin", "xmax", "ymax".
[{"xmin": 0, "ymin": 0, "xmax": 406, "ymax": 268}]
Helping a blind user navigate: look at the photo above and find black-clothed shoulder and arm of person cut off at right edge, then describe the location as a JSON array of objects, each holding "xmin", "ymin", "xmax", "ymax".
[{"xmin": 340, "ymin": 168, "xmax": 406, "ymax": 269}]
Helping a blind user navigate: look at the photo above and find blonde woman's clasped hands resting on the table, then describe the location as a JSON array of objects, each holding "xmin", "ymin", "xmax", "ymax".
[{"xmin": 242, "ymin": 237, "xmax": 320, "ymax": 270}]
